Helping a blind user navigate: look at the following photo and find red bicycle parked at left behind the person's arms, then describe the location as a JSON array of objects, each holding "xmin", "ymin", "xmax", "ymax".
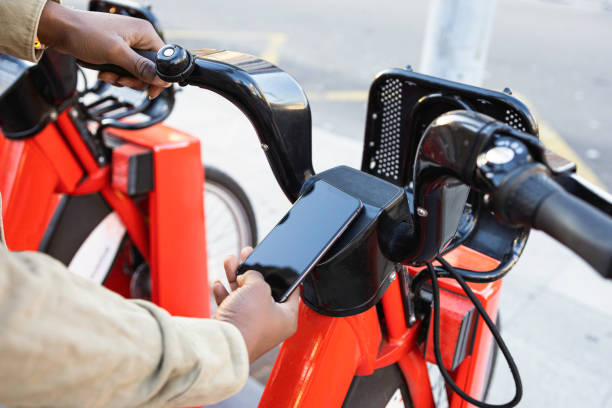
[{"xmin": 0, "ymin": 34, "xmax": 257, "ymax": 317}]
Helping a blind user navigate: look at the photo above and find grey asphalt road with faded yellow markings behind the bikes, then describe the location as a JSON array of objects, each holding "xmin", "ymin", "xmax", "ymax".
[{"xmin": 145, "ymin": 0, "xmax": 612, "ymax": 189}]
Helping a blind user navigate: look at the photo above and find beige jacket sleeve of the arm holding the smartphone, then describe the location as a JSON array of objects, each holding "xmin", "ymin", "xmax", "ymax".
[{"xmin": 0, "ymin": 194, "xmax": 248, "ymax": 407}]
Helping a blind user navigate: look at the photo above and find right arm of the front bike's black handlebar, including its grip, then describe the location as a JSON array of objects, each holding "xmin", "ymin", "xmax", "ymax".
[{"xmin": 408, "ymin": 111, "xmax": 612, "ymax": 278}]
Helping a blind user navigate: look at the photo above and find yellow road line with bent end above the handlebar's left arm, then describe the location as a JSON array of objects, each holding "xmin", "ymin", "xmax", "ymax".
[{"xmin": 164, "ymin": 29, "xmax": 287, "ymax": 64}]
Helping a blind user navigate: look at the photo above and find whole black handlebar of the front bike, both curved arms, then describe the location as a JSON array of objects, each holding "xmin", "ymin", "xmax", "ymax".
[{"xmin": 79, "ymin": 49, "xmax": 612, "ymax": 278}]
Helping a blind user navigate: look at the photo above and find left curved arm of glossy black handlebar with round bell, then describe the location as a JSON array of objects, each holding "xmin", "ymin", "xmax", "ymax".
[{"xmin": 79, "ymin": 45, "xmax": 314, "ymax": 202}]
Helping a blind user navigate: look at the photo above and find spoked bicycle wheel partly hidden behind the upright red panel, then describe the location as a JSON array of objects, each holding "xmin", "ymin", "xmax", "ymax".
[{"xmin": 204, "ymin": 166, "xmax": 257, "ymax": 285}]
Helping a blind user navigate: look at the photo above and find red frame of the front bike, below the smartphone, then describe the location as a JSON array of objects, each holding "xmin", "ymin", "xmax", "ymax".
[{"xmin": 259, "ymin": 247, "xmax": 502, "ymax": 408}]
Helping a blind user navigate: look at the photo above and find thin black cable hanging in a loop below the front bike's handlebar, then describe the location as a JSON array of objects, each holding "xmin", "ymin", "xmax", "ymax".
[{"xmin": 427, "ymin": 256, "xmax": 523, "ymax": 408}]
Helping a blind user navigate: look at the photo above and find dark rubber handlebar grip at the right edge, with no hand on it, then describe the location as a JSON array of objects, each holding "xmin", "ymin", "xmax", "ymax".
[{"xmin": 533, "ymin": 190, "xmax": 612, "ymax": 279}]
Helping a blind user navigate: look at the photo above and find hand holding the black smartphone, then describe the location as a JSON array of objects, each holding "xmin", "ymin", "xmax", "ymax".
[{"xmin": 213, "ymin": 247, "xmax": 300, "ymax": 362}]
